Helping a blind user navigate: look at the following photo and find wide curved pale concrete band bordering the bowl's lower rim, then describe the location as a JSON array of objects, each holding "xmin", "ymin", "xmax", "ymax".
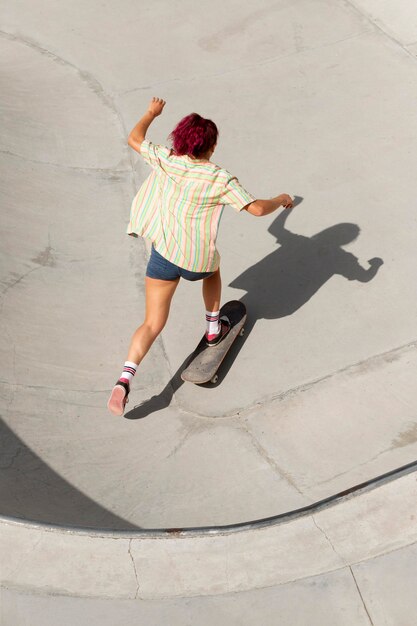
[{"xmin": 0, "ymin": 472, "xmax": 417, "ymax": 599}]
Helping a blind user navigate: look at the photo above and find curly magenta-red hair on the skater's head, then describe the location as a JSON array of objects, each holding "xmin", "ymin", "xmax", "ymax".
[{"xmin": 169, "ymin": 113, "xmax": 219, "ymax": 158}]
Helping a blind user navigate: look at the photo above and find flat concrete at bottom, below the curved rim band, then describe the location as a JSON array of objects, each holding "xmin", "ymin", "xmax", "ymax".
[{"xmin": 1, "ymin": 544, "xmax": 417, "ymax": 626}]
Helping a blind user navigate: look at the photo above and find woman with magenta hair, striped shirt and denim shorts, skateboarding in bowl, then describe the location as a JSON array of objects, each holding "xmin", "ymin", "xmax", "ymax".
[{"xmin": 107, "ymin": 98, "xmax": 292, "ymax": 415}]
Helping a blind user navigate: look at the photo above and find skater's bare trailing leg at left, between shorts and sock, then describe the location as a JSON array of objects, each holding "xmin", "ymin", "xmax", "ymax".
[{"xmin": 127, "ymin": 276, "xmax": 179, "ymax": 365}]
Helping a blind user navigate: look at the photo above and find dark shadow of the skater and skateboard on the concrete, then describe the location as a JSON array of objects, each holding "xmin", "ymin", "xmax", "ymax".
[{"xmin": 125, "ymin": 197, "xmax": 383, "ymax": 419}]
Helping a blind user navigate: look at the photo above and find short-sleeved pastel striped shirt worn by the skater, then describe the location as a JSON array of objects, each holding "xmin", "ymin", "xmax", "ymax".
[{"xmin": 127, "ymin": 140, "xmax": 255, "ymax": 272}]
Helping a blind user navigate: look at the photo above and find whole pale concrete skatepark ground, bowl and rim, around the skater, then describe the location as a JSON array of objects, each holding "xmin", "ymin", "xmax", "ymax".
[{"xmin": 0, "ymin": 0, "xmax": 417, "ymax": 626}]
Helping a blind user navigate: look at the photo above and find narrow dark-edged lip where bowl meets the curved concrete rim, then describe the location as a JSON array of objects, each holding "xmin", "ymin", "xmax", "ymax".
[{"xmin": 0, "ymin": 461, "xmax": 417, "ymax": 539}]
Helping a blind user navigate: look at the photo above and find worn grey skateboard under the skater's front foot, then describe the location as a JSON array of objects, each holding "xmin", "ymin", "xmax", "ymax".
[{"xmin": 181, "ymin": 300, "xmax": 246, "ymax": 385}]
